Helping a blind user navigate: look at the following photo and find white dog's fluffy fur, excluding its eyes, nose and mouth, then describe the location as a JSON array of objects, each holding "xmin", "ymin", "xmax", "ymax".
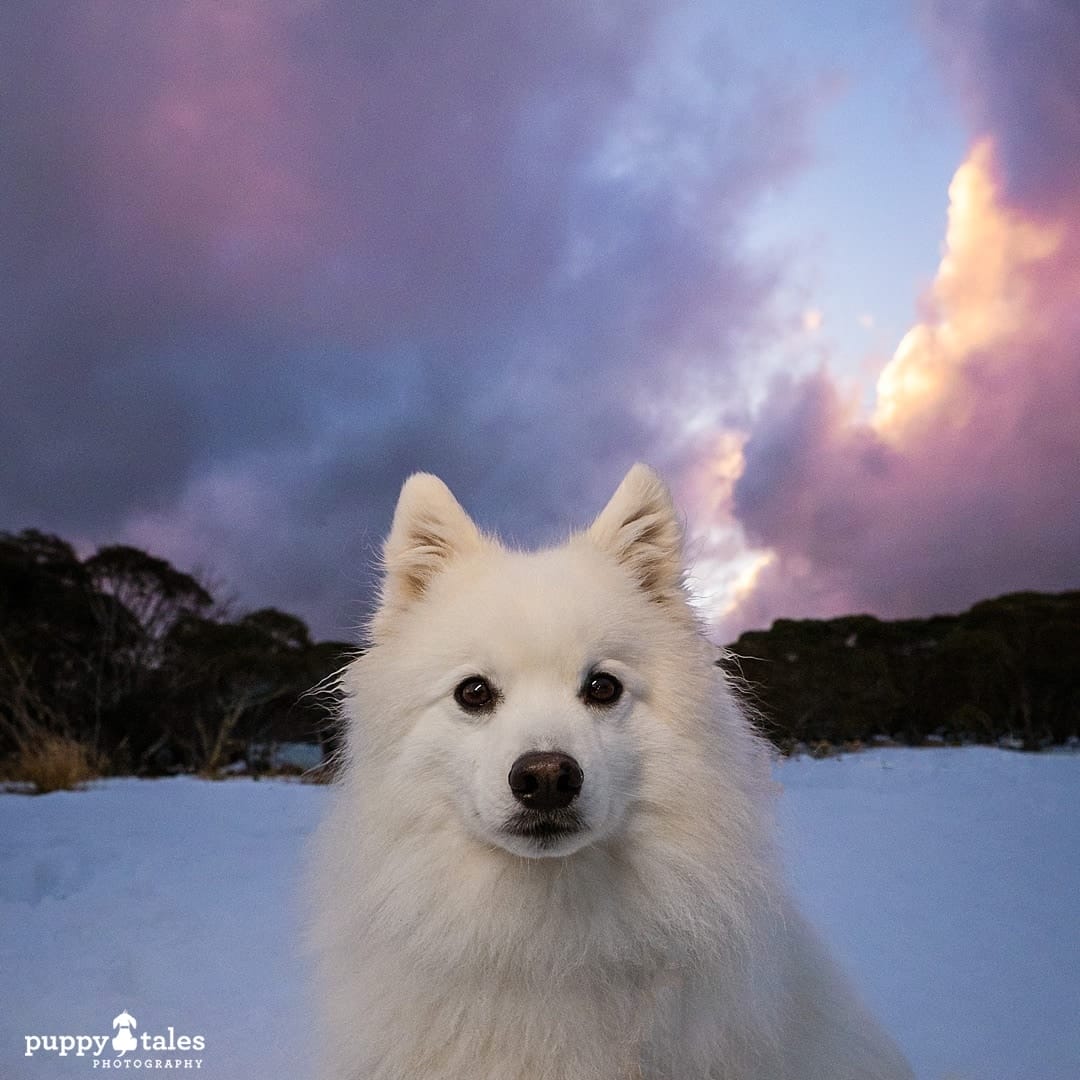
[{"xmin": 312, "ymin": 465, "xmax": 912, "ymax": 1080}]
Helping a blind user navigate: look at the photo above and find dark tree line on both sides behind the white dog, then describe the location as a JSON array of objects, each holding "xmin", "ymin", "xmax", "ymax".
[{"xmin": 0, "ymin": 529, "xmax": 1080, "ymax": 775}]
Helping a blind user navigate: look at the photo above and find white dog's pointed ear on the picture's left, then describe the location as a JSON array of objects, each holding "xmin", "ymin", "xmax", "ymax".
[{"xmin": 372, "ymin": 473, "xmax": 484, "ymax": 640}]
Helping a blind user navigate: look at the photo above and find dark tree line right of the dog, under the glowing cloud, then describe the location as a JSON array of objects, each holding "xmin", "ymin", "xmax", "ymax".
[{"xmin": 721, "ymin": 592, "xmax": 1080, "ymax": 750}]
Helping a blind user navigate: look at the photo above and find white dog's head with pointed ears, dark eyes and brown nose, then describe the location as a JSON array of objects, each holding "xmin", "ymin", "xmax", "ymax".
[{"xmin": 349, "ymin": 465, "xmax": 714, "ymax": 858}]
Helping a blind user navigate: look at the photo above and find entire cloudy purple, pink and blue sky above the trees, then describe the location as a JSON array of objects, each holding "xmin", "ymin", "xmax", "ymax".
[{"xmin": 0, "ymin": 0, "xmax": 1080, "ymax": 640}]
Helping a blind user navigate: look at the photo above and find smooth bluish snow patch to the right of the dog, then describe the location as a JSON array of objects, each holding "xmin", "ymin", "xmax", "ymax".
[{"xmin": 780, "ymin": 747, "xmax": 1080, "ymax": 1080}]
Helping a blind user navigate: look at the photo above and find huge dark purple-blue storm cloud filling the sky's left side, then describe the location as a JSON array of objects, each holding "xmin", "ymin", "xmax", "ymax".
[{"xmin": 0, "ymin": 0, "xmax": 805, "ymax": 632}]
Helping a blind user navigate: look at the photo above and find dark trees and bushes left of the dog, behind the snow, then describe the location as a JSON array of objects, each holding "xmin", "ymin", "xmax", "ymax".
[{"xmin": 0, "ymin": 529, "xmax": 350, "ymax": 775}]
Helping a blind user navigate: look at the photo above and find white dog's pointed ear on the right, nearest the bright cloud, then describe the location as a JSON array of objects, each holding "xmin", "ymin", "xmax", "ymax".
[{"xmin": 588, "ymin": 464, "xmax": 685, "ymax": 600}]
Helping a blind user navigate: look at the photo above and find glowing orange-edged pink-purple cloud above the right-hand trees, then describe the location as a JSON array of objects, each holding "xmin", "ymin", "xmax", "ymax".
[{"xmin": 725, "ymin": 138, "xmax": 1080, "ymax": 632}]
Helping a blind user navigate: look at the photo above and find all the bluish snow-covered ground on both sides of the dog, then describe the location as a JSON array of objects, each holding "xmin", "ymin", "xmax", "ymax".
[{"xmin": 0, "ymin": 747, "xmax": 1080, "ymax": 1080}]
